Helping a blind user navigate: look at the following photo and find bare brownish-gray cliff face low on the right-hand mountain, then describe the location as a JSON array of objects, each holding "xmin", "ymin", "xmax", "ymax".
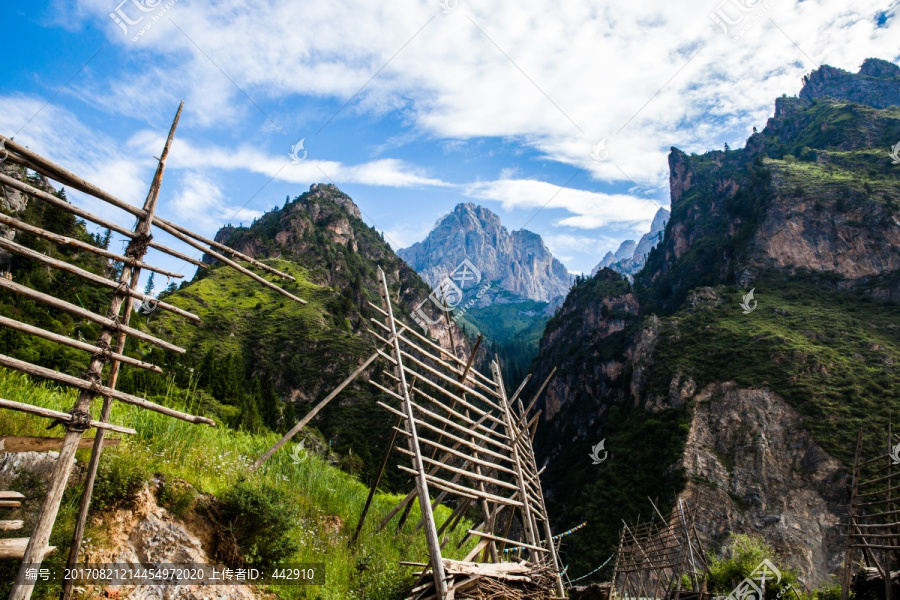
[{"xmin": 681, "ymin": 383, "xmax": 847, "ymax": 586}]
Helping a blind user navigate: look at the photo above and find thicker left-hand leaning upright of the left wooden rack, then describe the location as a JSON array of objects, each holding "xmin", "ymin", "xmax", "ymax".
[{"xmin": 9, "ymin": 103, "xmax": 184, "ymax": 600}]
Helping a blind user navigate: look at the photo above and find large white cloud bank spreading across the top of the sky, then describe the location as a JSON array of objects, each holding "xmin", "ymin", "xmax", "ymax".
[{"xmin": 63, "ymin": 0, "xmax": 900, "ymax": 192}]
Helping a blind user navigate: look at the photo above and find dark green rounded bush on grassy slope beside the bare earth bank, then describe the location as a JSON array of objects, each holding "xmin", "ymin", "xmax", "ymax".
[{"xmin": 221, "ymin": 482, "xmax": 300, "ymax": 567}]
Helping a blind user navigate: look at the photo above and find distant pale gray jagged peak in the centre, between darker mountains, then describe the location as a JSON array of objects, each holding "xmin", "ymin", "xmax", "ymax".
[{"xmin": 397, "ymin": 203, "xmax": 572, "ymax": 302}]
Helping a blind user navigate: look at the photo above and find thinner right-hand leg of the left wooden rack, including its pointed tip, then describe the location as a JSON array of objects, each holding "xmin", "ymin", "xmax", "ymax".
[{"xmin": 61, "ymin": 101, "xmax": 184, "ymax": 600}]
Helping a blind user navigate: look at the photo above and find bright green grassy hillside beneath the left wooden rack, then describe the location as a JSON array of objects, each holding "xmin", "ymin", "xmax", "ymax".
[{"xmin": 0, "ymin": 370, "xmax": 474, "ymax": 600}]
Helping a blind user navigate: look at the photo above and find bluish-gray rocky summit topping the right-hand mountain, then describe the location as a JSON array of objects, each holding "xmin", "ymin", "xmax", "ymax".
[{"xmin": 800, "ymin": 58, "xmax": 900, "ymax": 108}]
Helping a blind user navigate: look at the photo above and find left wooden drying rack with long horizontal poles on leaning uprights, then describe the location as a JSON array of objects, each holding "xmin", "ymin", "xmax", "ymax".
[{"xmin": 0, "ymin": 102, "xmax": 305, "ymax": 600}]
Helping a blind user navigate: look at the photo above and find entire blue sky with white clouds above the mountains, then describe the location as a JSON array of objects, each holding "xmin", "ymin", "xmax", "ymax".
[{"xmin": 0, "ymin": 0, "xmax": 900, "ymax": 288}]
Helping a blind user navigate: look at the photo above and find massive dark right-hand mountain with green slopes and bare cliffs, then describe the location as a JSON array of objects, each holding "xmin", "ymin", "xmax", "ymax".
[{"xmin": 523, "ymin": 61, "xmax": 900, "ymax": 587}]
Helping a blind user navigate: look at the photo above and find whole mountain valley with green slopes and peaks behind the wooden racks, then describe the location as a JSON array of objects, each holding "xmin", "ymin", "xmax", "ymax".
[{"xmin": 0, "ymin": 54, "xmax": 900, "ymax": 600}]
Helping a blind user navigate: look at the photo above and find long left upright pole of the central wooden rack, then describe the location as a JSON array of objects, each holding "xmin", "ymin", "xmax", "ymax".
[{"xmin": 378, "ymin": 267, "xmax": 447, "ymax": 600}]
